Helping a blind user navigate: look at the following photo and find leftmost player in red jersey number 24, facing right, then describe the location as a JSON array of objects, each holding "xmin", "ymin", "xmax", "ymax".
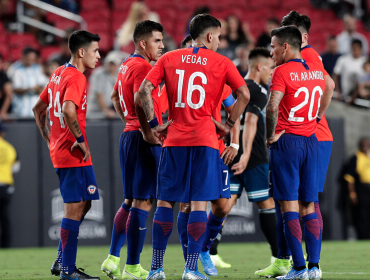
[{"xmin": 33, "ymin": 30, "xmax": 100, "ymax": 280}]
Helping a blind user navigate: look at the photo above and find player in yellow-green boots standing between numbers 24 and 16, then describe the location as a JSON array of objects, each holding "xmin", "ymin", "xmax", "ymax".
[{"xmin": 101, "ymin": 20, "xmax": 164, "ymax": 279}]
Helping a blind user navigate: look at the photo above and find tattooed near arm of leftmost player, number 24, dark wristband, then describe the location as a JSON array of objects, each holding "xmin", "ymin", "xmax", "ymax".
[{"xmin": 62, "ymin": 100, "xmax": 90, "ymax": 162}]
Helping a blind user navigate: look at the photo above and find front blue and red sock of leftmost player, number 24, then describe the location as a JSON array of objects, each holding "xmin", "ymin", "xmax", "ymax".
[{"xmin": 60, "ymin": 218, "xmax": 80, "ymax": 274}]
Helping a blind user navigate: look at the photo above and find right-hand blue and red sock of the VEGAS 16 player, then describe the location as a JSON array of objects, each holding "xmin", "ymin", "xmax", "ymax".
[{"xmin": 185, "ymin": 211, "xmax": 207, "ymax": 271}]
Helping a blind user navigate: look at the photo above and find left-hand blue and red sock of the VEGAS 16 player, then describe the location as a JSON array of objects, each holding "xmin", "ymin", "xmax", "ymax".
[{"xmin": 151, "ymin": 207, "xmax": 173, "ymax": 270}]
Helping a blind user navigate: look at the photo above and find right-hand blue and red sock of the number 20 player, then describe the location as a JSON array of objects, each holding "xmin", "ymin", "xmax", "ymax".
[{"xmin": 302, "ymin": 212, "xmax": 321, "ymax": 263}]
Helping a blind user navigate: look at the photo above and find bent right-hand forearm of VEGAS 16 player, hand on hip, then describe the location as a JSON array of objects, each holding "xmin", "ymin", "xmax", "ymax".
[{"xmin": 212, "ymin": 85, "xmax": 250, "ymax": 137}]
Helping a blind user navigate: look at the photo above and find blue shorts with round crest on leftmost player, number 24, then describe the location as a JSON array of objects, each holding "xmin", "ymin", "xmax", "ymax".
[{"xmin": 55, "ymin": 165, "xmax": 99, "ymax": 203}]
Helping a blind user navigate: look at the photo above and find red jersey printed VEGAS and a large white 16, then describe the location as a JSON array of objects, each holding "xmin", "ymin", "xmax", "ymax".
[{"xmin": 145, "ymin": 47, "xmax": 245, "ymax": 150}]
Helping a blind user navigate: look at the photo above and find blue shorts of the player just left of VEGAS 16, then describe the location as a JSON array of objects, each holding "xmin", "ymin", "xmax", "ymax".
[{"xmin": 119, "ymin": 131, "xmax": 162, "ymax": 199}]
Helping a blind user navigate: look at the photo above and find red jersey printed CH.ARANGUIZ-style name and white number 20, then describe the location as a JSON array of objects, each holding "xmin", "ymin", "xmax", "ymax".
[{"xmin": 270, "ymin": 59, "xmax": 325, "ymax": 137}]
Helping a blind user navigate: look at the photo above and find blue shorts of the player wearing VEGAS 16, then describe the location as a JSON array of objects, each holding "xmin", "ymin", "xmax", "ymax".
[{"xmin": 157, "ymin": 146, "xmax": 224, "ymax": 203}]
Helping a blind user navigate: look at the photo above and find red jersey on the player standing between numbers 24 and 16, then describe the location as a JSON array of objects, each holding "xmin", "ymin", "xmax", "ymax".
[{"xmin": 114, "ymin": 54, "xmax": 162, "ymax": 132}]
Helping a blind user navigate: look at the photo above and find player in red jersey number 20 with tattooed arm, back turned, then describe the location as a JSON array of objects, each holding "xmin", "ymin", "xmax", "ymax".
[{"xmin": 266, "ymin": 26, "xmax": 330, "ymax": 279}]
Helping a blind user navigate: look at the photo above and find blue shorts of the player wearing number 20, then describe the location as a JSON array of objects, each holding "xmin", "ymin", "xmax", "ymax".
[{"xmin": 270, "ymin": 134, "xmax": 319, "ymax": 202}]
